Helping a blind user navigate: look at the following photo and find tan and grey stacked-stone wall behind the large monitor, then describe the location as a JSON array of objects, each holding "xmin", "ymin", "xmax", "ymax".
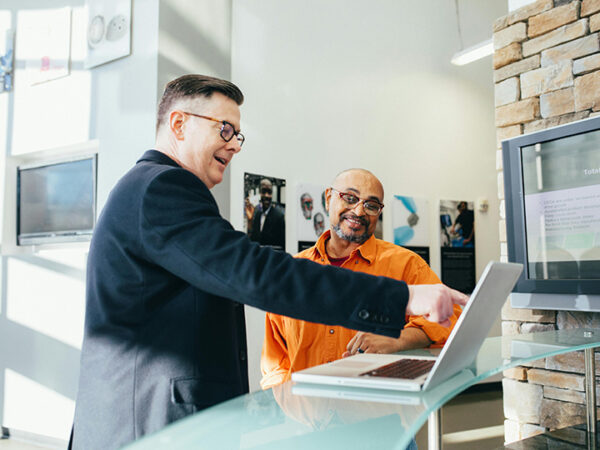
[{"xmin": 493, "ymin": 0, "xmax": 600, "ymax": 442}]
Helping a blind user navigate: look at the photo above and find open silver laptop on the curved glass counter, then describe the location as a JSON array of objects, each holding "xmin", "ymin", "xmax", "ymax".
[{"xmin": 292, "ymin": 262, "xmax": 523, "ymax": 391}]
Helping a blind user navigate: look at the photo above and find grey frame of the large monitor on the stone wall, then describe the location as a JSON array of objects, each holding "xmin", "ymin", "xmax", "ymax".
[{"xmin": 502, "ymin": 117, "xmax": 600, "ymax": 295}]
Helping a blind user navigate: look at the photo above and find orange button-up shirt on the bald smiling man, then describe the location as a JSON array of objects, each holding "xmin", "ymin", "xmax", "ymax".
[{"xmin": 260, "ymin": 230, "xmax": 461, "ymax": 389}]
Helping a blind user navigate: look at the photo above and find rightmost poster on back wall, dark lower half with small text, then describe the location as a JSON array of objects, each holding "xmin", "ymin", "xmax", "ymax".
[{"xmin": 440, "ymin": 200, "xmax": 475, "ymax": 294}]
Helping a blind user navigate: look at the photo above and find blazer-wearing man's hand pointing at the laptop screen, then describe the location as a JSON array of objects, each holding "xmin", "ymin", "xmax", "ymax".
[{"xmin": 406, "ymin": 284, "xmax": 469, "ymax": 327}]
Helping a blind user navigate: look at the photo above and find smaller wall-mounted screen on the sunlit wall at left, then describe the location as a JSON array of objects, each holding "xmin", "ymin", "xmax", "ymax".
[{"xmin": 17, "ymin": 155, "xmax": 96, "ymax": 245}]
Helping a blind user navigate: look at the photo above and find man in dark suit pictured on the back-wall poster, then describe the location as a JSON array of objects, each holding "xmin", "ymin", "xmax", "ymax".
[{"xmin": 248, "ymin": 178, "xmax": 285, "ymax": 250}]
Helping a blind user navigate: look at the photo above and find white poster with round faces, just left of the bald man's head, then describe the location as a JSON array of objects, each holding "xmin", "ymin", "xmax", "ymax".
[{"xmin": 296, "ymin": 183, "xmax": 329, "ymax": 252}]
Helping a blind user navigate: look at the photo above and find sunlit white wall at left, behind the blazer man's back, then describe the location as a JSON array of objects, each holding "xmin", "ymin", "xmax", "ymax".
[{"xmin": 0, "ymin": 0, "xmax": 158, "ymax": 439}]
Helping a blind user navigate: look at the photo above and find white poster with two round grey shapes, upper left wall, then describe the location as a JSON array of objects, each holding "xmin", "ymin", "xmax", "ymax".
[{"xmin": 84, "ymin": 0, "xmax": 131, "ymax": 69}]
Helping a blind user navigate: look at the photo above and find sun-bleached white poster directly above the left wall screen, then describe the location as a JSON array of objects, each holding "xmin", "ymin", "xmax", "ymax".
[{"xmin": 16, "ymin": 8, "xmax": 71, "ymax": 85}]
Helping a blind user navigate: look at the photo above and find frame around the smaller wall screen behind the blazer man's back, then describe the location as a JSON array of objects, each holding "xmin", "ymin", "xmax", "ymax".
[{"xmin": 16, "ymin": 153, "xmax": 98, "ymax": 246}]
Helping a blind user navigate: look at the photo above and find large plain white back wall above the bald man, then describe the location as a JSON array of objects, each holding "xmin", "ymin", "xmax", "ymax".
[{"xmin": 231, "ymin": 0, "xmax": 506, "ymax": 389}]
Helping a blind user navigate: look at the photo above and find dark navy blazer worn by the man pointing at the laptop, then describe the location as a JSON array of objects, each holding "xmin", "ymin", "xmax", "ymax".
[{"xmin": 73, "ymin": 150, "xmax": 408, "ymax": 450}]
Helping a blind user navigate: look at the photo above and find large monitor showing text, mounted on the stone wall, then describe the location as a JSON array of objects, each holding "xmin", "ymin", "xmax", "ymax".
[{"xmin": 502, "ymin": 117, "xmax": 600, "ymax": 311}]
